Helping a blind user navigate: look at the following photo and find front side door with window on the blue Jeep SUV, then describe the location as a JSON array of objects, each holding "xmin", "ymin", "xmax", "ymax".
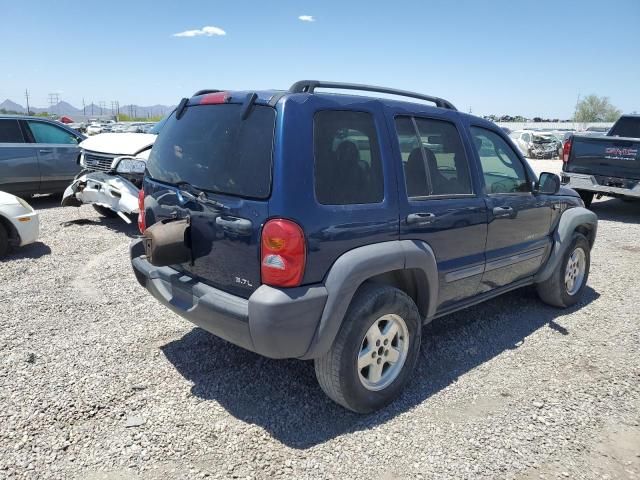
[{"xmin": 471, "ymin": 127, "xmax": 551, "ymax": 292}]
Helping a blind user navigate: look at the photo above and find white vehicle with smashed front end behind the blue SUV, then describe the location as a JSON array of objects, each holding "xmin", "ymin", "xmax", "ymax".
[{"xmin": 62, "ymin": 118, "xmax": 166, "ymax": 223}]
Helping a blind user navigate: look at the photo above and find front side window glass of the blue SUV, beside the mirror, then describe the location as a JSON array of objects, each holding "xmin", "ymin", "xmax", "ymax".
[{"xmin": 471, "ymin": 127, "xmax": 531, "ymax": 194}]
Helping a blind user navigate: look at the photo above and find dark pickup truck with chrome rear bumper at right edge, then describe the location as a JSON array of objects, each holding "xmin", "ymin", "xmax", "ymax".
[{"xmin": 561, "ymin": 115, "xmax": 640, "ymax": 207}]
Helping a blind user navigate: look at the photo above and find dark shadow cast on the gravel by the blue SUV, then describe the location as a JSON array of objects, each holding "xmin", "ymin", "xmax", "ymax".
[{"xmin": 161, "ymin": 287, "xmax": 599, "ymax": 449}]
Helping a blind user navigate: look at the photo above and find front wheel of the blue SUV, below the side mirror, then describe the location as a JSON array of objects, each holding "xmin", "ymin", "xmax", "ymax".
[{"xmin": 536, "ymin": 232, "xmax": 591, "ymax": 308}]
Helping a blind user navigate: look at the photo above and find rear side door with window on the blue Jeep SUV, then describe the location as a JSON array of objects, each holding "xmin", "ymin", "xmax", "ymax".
[{"xmin": 395, "ymin": 116, "xmax": 487, "ymax": 308}]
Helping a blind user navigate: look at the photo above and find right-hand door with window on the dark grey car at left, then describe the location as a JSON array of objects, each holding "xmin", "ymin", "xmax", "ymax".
[{"xmin": 26, "ymin": 120, "xmax": 81, "ymax": 193}]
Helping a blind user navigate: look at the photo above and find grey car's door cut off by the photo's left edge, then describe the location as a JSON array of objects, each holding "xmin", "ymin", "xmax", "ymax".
[{"xmin": 0, "ymin": 119, "xmax": 40, "ymax": 195}]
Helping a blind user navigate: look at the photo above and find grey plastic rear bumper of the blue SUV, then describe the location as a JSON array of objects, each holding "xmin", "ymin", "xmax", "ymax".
[{"xmin": 130, "ymin": 239, "xmax": 327, "ymax": 358}]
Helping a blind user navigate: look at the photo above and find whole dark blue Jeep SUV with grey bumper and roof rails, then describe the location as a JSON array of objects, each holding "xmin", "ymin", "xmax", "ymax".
[{"xmin": 131, "ymin": 81, "xmax": 597, "ymax": 412}]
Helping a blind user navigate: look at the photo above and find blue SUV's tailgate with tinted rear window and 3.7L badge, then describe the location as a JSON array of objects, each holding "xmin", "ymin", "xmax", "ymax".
[{"xmin": 144, "ymin": 101, "xmax": 276, "ymax": 298}]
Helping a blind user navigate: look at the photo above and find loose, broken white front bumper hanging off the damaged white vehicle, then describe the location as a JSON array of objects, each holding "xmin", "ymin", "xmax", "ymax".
[{"xmin": 62, "ymin": 172, "xmax": 140, "ymax": 223}]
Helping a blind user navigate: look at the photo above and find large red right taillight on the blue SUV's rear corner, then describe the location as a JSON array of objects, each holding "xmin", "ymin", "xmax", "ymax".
[{"xmin": 260, "ymin": 218, "xmax": 307, "ymax": 287}]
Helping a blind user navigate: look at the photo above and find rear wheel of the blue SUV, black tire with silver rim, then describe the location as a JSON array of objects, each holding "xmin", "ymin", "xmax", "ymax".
[{"xmin": 314, "ymin": 284, "xmax": 422, "ymax": 413}]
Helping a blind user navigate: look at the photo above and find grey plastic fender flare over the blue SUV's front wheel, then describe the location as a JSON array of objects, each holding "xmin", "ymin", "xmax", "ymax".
[{"xmin": 534, "ymin": 207, "xmax": 598, "ymax": 283}]
